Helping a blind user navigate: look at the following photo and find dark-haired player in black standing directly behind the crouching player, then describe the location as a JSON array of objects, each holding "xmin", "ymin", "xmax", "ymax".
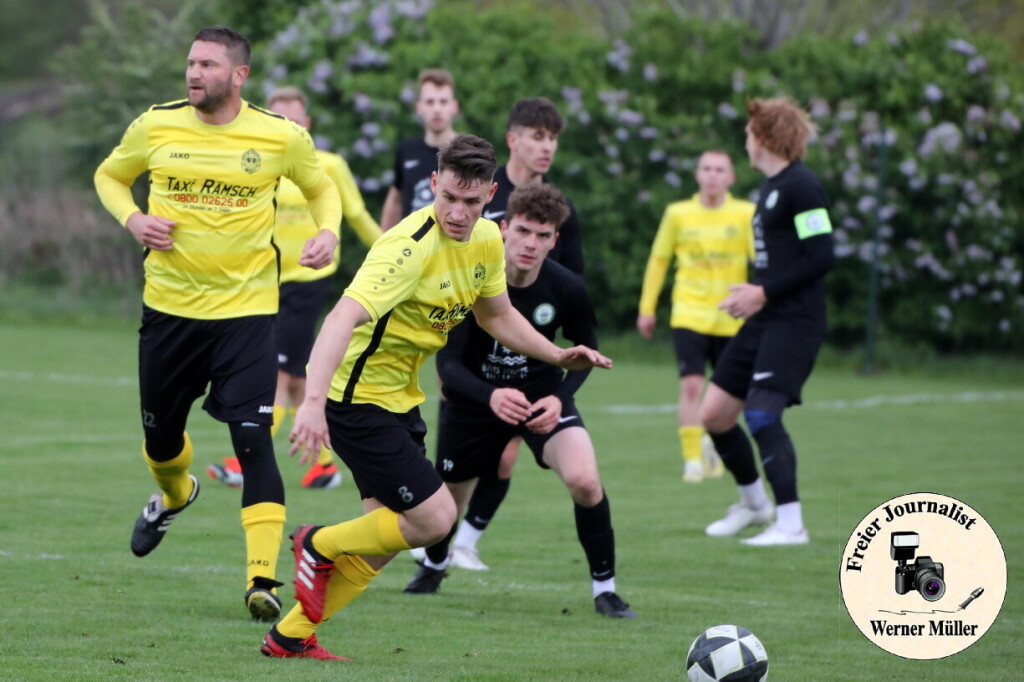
[{"xmin": 430, "ymin": 97, "xmax": 583, "ymax": 570}]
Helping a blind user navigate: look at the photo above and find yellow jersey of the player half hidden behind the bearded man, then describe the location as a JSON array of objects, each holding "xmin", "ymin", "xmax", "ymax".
[{"xmin": 273, "ymin": 151, "xmax": 381, "ymax": 283}]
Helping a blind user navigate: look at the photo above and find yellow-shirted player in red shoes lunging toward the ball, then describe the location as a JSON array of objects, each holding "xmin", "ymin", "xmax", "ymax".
[{"xmin": 260, "ymin": 135, "xmax": 611, "ymax": 659}]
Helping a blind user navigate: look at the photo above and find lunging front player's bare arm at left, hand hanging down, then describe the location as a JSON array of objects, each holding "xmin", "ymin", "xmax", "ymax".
[{"xmin": 288, "ymin": 296, "xmax": 371, "ymax": 464}]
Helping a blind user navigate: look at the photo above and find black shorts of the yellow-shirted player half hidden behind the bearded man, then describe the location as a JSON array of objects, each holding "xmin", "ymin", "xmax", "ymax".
[{"xmin": 276, "ymin": 278, "xmax": 331, "ymax": 377}]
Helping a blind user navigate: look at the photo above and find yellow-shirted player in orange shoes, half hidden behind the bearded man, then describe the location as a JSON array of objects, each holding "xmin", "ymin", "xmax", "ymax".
[{"xmin": 207, "ymin": 87, "xmax": 381, "ymax": 488}]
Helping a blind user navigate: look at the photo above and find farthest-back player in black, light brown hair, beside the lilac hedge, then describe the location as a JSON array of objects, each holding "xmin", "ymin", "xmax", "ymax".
[{"xmin": 381, "ymin": 69, "xmax": 459, "ymax": 230}]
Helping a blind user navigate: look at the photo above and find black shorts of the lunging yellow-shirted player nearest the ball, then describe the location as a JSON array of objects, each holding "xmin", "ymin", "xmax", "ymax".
[{"xmin": 327, "ymin": 400, "xmax": 443, "ymax": 512}]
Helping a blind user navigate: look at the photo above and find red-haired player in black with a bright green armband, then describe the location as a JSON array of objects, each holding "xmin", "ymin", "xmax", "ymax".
[{"xmin": 700, "ymin": 97, "xmax": 835, "ymax": 546}]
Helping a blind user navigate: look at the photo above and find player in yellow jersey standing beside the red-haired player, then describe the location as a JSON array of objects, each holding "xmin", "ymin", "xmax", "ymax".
[{"xmin": 637, "ymin": 150, "xmax": 754, "ymax": 482}]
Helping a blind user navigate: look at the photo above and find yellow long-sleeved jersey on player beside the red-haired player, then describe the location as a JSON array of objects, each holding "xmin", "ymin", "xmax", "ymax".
[{"xmin": 640, "ymin": 194, "xmax": 756, "ymax": 336}]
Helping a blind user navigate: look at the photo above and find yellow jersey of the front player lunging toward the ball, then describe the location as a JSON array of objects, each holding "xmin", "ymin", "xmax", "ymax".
[{"xmin": 328, "ymin": 205, "xmax": 506, "ymax": 413}]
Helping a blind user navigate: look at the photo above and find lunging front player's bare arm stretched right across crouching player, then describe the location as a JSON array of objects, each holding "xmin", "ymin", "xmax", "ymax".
[{"xmin": 473, "ymin": 292, "xmax": 611, "ymax": 370}]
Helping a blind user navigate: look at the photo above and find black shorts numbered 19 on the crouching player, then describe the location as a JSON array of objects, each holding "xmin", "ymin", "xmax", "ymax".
[{"xmin": 434, "ymin": 400, "xmax": 586, "ymax": 483}]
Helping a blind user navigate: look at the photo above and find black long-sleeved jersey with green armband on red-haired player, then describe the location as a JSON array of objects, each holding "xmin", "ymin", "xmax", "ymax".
[{"xmin": 752, "ymin": 161, "xmax": 835, "ymax": 331}]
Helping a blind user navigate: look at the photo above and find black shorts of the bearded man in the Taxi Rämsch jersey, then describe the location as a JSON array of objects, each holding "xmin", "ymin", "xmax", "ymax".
[{"xmin": 138, "ymin": 306, "xmax": 278, "ymax": 434}]
